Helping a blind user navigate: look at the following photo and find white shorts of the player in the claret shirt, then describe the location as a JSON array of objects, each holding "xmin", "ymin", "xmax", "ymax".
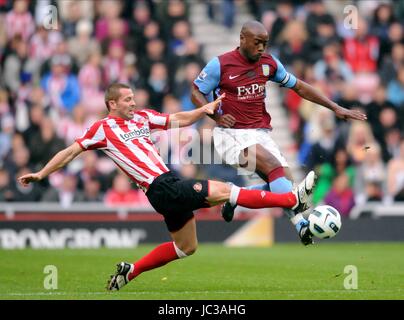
[{"xmin": 213, "ymin": 127, "xmax": 289, "ymax": 167}]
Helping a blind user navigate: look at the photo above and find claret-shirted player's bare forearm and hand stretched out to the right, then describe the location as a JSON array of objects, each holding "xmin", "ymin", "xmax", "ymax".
[{"xmin": 292, "ymin": 79, "xmax": 367, "ymax": 120}]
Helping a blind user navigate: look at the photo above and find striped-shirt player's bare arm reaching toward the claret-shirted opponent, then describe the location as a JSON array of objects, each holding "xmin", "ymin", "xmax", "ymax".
[{"xmin": 169, "ymin": 94, "xmax": 225, "ymax": 128}]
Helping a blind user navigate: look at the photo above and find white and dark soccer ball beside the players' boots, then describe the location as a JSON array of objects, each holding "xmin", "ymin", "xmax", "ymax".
[{"xmin": 308, "ymin": 205, "xmax": 341, "ymax": 239}]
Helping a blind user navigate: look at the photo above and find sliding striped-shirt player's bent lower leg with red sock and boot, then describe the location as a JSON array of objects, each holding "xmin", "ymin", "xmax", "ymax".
[{"xmin": 107, "ymin": 217, "xmax": 198, "ymax": 290}]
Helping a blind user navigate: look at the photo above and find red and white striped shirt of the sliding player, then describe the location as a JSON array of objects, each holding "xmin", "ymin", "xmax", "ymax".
[{"xmin": 76, "ymin": 109, "xmax": 169, "ymax": 191}]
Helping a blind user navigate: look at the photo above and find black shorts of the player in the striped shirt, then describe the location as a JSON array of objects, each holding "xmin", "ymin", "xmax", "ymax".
[{"xmin": 146, "ymin": 171, "xmax": 210, "ymax": 232}]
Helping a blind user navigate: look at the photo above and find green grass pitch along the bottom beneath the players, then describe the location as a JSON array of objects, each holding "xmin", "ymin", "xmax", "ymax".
[{"xmin": 0, "ymin": 242, "xmax": 404, "ymax": 300}]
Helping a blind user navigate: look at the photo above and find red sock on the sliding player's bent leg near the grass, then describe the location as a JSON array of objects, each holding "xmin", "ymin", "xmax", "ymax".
[{"xmin": 128, "ymin": 242, "xmax": 178, "ymax": 280}]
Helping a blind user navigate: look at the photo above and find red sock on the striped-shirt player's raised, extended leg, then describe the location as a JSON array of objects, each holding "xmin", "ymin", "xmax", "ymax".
[{"xmin": 237, "ymin": 189, "xmax": 296, "ymax": 209}]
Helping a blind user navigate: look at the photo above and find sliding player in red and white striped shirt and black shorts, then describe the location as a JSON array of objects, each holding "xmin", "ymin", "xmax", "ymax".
[{"xmin": 18, "ymin": 83, "xmax": 315, "ymax": 290}]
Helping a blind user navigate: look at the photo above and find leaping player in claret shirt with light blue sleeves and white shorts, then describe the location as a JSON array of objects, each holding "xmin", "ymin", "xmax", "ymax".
[{"xmin": 191, "ymin": 21, "xmax": 366, "ymax": 245}]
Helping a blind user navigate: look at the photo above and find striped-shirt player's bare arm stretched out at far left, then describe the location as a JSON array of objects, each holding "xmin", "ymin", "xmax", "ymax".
[{"xmin": 18, "ymin": 142, "xmax": 83, "ymax": 187}]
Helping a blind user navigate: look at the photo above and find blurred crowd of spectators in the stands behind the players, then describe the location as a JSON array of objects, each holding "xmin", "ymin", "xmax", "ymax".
[{"xmin": 0, "ymin": 0, "xmax": 404, "ymax": 215}]
